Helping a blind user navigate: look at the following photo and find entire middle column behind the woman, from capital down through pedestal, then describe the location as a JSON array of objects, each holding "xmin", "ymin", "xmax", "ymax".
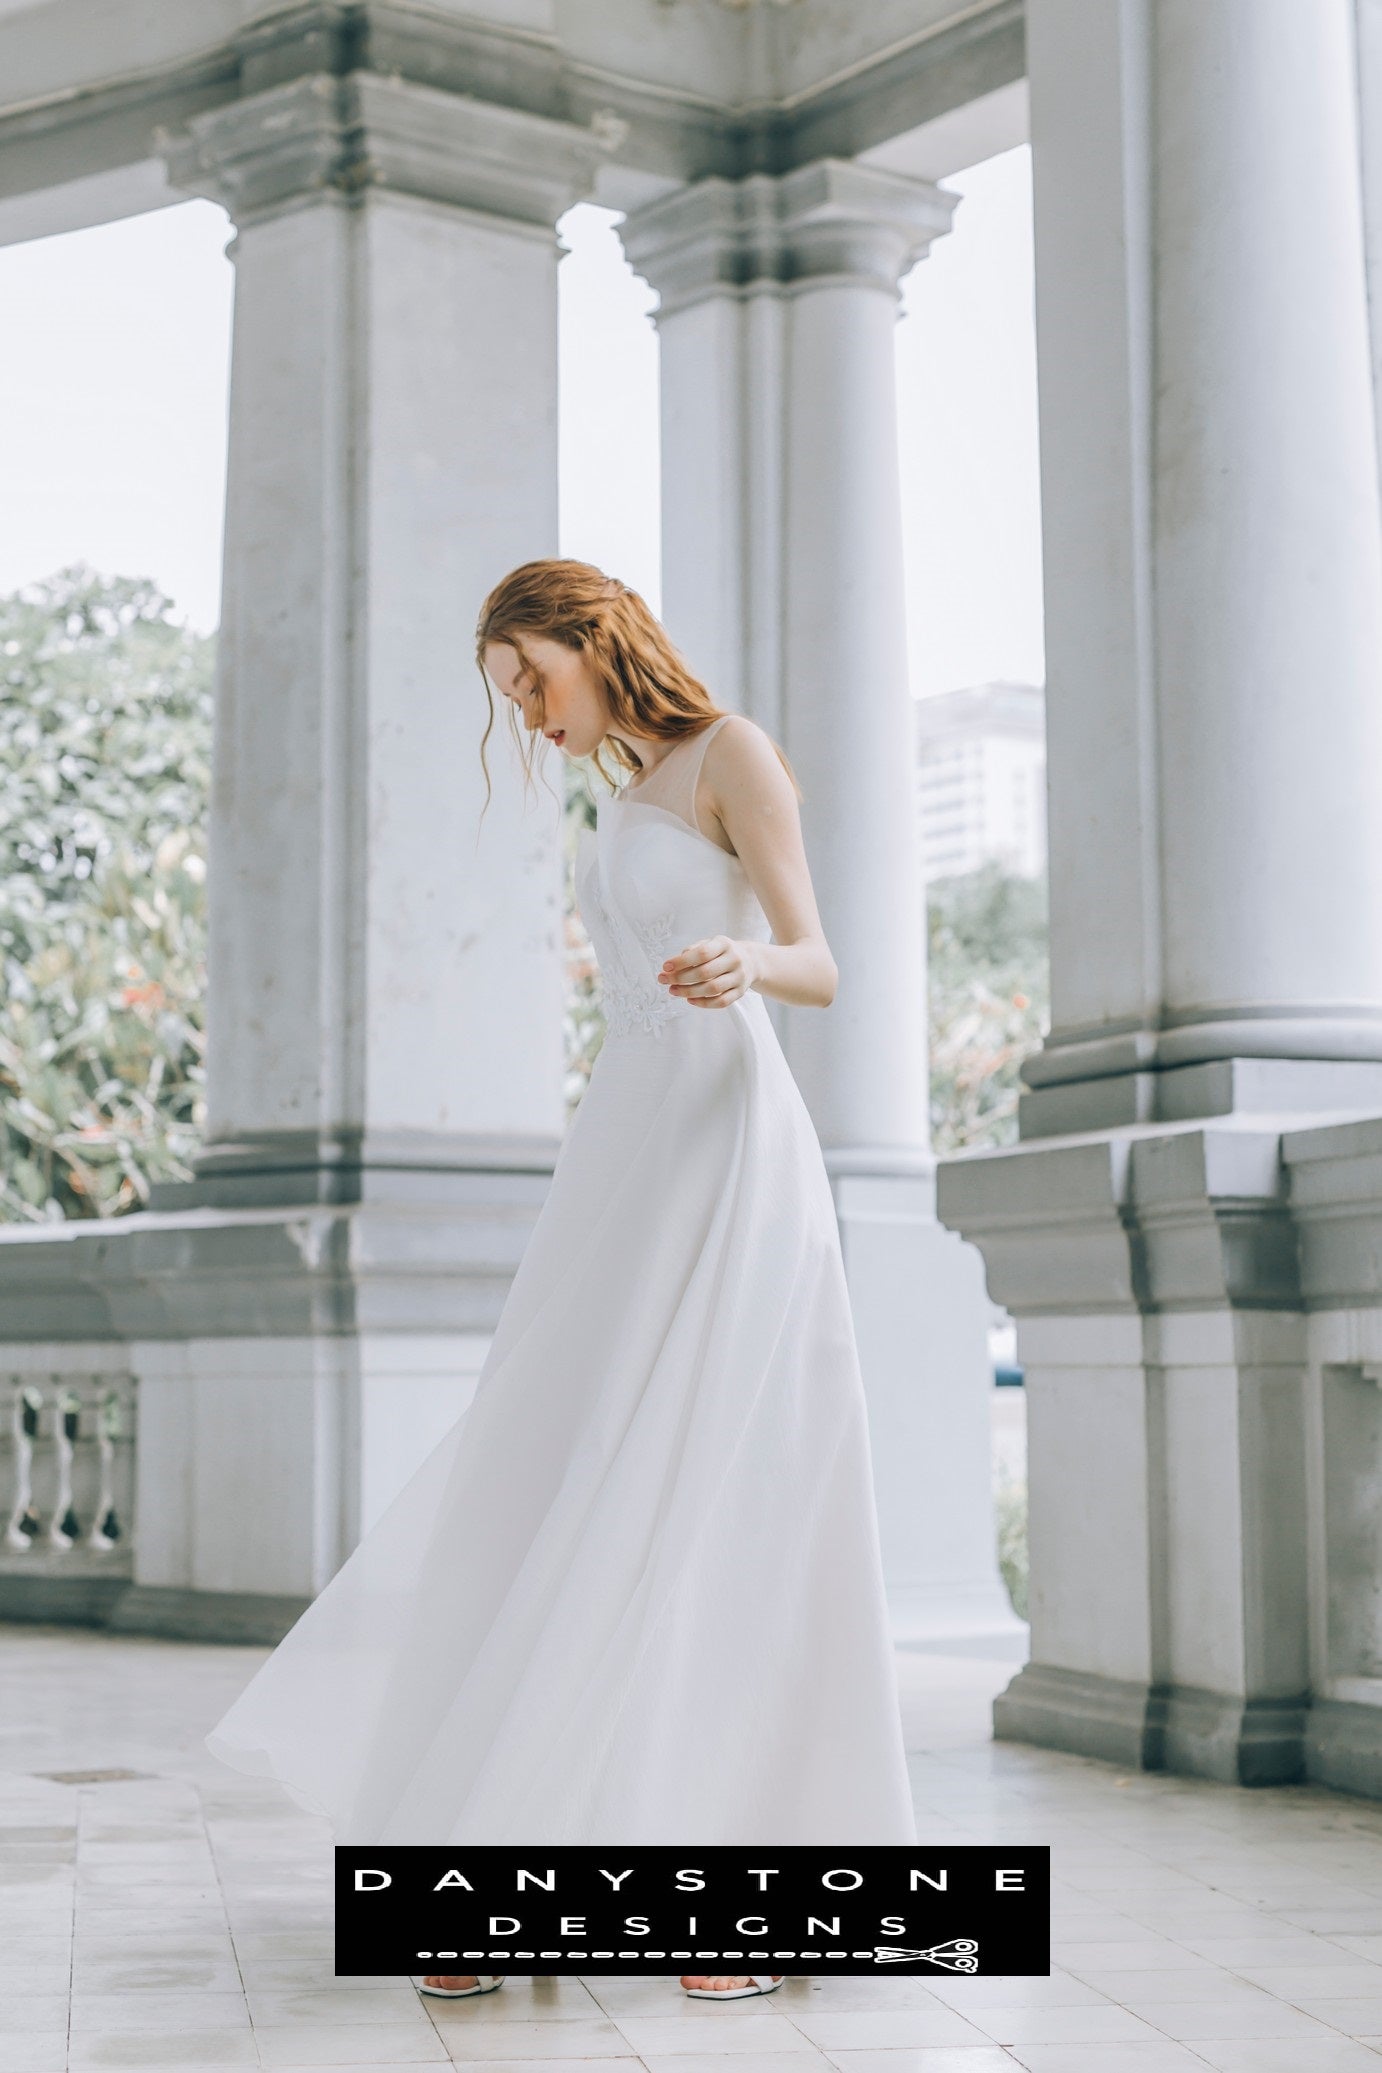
[{"xmin": 622, "ymin": 160, "xmax": 1017, "ymax": 1638}]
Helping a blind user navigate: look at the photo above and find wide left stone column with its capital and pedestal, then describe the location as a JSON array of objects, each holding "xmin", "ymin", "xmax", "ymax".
[{"xmin": 59, "ymin": 70, "xmax": 601, "ymax": 1640}]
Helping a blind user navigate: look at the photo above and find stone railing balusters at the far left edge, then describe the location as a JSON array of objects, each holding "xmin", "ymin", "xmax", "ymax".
[{"xmin": 0, "ymin": 1368, "xmax": 135, "ymax": 1578}]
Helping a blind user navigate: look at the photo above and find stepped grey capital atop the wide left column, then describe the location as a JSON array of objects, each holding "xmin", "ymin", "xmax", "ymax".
[{"xmin": 155, "ymin": 73, "xmax": 620, "ymax": 230}]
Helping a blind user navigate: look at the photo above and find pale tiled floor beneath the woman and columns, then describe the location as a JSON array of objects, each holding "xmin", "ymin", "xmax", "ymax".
[{"xmin": 0, "ymin": 1627, "xmax": 1382, "ymax": 2073}]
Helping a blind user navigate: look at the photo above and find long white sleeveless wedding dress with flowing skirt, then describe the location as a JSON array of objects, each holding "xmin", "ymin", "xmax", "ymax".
[{"xmin": 205, "ymin": 715, "xmax": 916, "ymax": 1845}]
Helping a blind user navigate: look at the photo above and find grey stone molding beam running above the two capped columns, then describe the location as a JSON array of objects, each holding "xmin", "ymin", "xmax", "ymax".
[{"xmin": 0, "ymin": 0, "xmax": 1026, "ymax": 219}]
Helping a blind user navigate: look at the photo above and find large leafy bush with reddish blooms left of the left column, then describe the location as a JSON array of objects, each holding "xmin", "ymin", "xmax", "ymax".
[{"xmin": 0, "ymin": 568, "xmax": 213, "ymax": 1223}]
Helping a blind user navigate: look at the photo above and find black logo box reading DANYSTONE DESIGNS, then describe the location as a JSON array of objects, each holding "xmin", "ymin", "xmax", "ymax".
[{"xmin": 336, "ymin": 1843, "xmax": 1050, "ymax": 1978}]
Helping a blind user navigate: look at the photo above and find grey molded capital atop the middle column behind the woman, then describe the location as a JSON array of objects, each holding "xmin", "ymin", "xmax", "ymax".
[{"xmin": 620, "ymin": 158, "xmax": 959, "ymax": 317}]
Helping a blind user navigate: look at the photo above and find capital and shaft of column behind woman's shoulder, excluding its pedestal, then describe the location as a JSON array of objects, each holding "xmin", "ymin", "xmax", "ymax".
[{"xmin": 622, "ymin": 160, "xmax": 955, "ymax": 1167}]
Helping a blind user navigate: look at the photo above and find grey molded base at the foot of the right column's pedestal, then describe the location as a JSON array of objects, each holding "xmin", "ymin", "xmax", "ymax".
[{"xmin": 992, "ymin": 1663, "xmax": 1309, "ymax": 1785}]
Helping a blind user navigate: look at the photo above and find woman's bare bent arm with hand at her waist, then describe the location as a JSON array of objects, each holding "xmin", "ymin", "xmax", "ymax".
[{"xmin": 657, "ymin": 713, "xmax": 839, "ymax": 1007}]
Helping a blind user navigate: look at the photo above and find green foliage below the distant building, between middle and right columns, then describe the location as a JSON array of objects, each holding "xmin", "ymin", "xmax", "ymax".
[{"xmin": 928, "ymin": 864, "xmax": 1048, "ymax": 1153}]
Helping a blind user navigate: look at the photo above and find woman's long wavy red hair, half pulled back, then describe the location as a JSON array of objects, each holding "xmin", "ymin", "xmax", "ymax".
[{"xmin": 474, "ymin": 560, "xmax": 802, "ymax": 804}]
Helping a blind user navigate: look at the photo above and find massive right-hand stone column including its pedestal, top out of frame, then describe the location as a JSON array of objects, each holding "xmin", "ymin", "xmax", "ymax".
[{"xmin": 939, "ymin": 0, "xmax": 1382, "ymax": 1783}]
